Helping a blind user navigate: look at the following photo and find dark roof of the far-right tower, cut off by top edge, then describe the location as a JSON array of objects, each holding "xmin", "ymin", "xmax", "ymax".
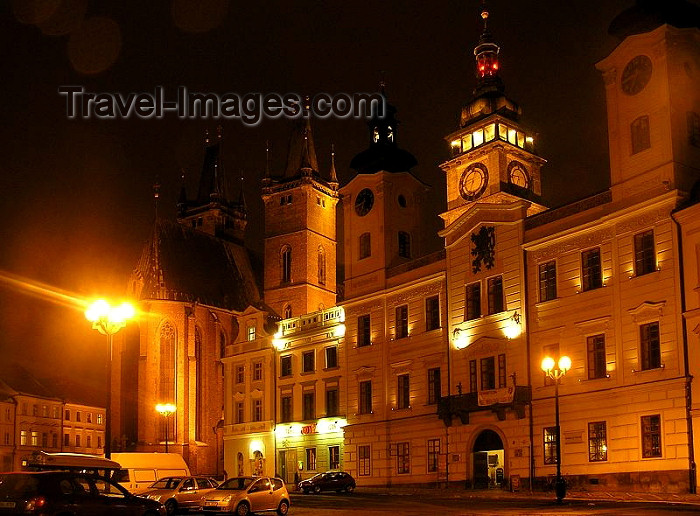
[{"xmin": 608, "ymin": 0, "xmax": 700, "ymax": 39}]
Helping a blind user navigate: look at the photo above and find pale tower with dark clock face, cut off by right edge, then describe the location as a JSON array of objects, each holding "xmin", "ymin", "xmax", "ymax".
[{"xmin": 597, "ymin": 0, "xmax": 700, "ymax": 201}]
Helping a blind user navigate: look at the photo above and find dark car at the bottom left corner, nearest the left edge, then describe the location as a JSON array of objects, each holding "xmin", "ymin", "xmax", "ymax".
[{"xmin": 0, "ymin": 471, "xmax": 165, "ymax": 516}]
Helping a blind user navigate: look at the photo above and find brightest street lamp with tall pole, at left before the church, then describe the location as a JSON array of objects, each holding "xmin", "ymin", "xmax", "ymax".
[{"xmin": 85, "ymin": 299, "xmax": 135, "ymax": 459}]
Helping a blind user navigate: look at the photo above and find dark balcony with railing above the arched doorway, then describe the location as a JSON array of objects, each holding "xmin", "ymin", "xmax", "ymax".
[{"xmin": 438, "ymin": 385, "xmax": 532, "ymax": 426}]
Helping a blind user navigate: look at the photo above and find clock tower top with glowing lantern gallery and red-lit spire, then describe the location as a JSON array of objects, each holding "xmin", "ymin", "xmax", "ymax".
[{"xmin": 441, "ymin": 9, "xmax": 545, "ymax": 230}]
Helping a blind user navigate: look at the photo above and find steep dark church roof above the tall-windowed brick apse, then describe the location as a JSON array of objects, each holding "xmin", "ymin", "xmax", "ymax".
[{"xmin": 132, "ymin": 219, "xmax": 260, "ymax": 311}]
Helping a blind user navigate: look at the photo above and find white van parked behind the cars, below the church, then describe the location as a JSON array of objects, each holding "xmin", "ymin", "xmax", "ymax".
[{"xmin": 112, "ymin": 452, "xmax": 190, "ymax": 493}]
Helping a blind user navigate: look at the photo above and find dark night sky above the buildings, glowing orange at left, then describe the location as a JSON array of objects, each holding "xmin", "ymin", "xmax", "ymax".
[{"xmin": 0, "ymin": 0, "xmax": 644, "ymax": 394}]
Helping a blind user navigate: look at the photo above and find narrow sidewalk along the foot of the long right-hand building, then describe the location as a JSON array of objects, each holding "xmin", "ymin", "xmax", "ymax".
[{"xmin": 357, "ymin": 487, "xmax": 700, "ymax": 506}]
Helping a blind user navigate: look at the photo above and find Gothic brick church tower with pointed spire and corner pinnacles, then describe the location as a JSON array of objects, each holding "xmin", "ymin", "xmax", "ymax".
[{"xmin": 262, "ymin": 112, "xmax": 338, "ymax": 319}]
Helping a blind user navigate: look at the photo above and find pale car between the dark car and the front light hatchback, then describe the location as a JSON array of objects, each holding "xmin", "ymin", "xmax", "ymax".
[{"xmin": 134, "ymin": 477, "xmax": 219, "ymax": 516}]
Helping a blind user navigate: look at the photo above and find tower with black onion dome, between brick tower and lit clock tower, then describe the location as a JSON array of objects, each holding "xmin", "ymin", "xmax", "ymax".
[{"xmin": 341, "ymin": 85, "xmax": 428, "ymax": 299}]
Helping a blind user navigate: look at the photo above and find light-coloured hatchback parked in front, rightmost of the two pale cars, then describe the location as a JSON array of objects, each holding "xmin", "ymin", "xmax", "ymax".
[{"xmin": 202, "ymin": 477, "xmax": 289, "ymax": 516}]
